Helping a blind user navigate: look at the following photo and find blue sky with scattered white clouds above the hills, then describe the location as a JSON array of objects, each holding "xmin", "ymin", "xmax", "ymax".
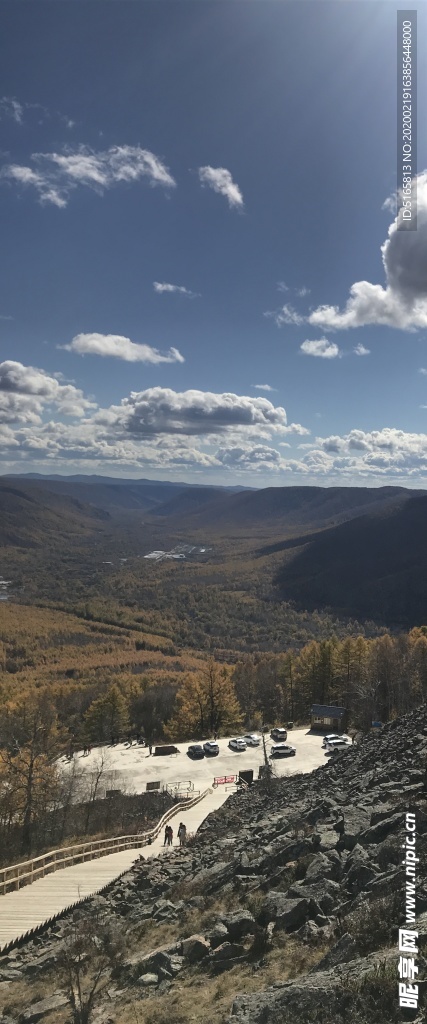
[{"xmin": 0, "ymin": 0, "xmax": 427, "ymax": 486}]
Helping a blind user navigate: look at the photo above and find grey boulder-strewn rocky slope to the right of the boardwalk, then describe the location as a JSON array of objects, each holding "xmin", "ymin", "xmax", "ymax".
[{"xmin": 0, "ymin": 706, "xmax": 427, "ymax": 1024}]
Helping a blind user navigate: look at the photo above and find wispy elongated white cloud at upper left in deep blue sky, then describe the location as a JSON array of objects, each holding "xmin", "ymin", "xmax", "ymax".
[{"xmin": 0, "ymin": 145, "xmax": 176, "ymax": 207}]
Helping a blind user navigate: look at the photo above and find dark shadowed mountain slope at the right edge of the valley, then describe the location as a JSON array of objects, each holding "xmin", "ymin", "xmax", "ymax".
[{"xmin": 275, "ymin": 494, "xmax": 427, "ymax": 627}]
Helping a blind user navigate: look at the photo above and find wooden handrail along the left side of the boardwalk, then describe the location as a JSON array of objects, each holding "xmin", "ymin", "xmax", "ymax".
[{"xmin": 0, "ymin": 788, "xmax": 210, "ymax": 895}]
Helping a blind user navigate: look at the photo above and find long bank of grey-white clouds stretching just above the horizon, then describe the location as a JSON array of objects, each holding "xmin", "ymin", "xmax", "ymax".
[{"xmin": 0, "ymin": 360, "xmax": 427, "ymax": 485}]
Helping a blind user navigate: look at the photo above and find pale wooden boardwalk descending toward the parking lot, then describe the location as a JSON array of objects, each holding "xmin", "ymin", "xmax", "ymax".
[{"xmin": 0, "ymin": 787, "xmax": 229, "ymax": 950}]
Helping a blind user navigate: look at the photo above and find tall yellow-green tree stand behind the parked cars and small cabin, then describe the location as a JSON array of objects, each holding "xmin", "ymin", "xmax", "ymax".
[{"xmin": 232, "ymin": 627, "xmax": 427, "ymax": 729}]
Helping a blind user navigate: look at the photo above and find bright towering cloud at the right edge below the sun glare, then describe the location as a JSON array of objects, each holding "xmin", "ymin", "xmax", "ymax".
[{"xmin": 307, "ymin": 171, "xmax": 427, "ymax": 331}]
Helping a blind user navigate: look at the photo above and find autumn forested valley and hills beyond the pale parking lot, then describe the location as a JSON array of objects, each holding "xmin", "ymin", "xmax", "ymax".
[{"xmin": 0, "ymin": 480, "xmax": 427, "ymax": 862}]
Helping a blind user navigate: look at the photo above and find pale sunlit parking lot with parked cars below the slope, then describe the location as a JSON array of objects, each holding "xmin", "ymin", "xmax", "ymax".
[{"xmin": 62, "ymin": 727, "xmax": 328, "ymax": 796}]
